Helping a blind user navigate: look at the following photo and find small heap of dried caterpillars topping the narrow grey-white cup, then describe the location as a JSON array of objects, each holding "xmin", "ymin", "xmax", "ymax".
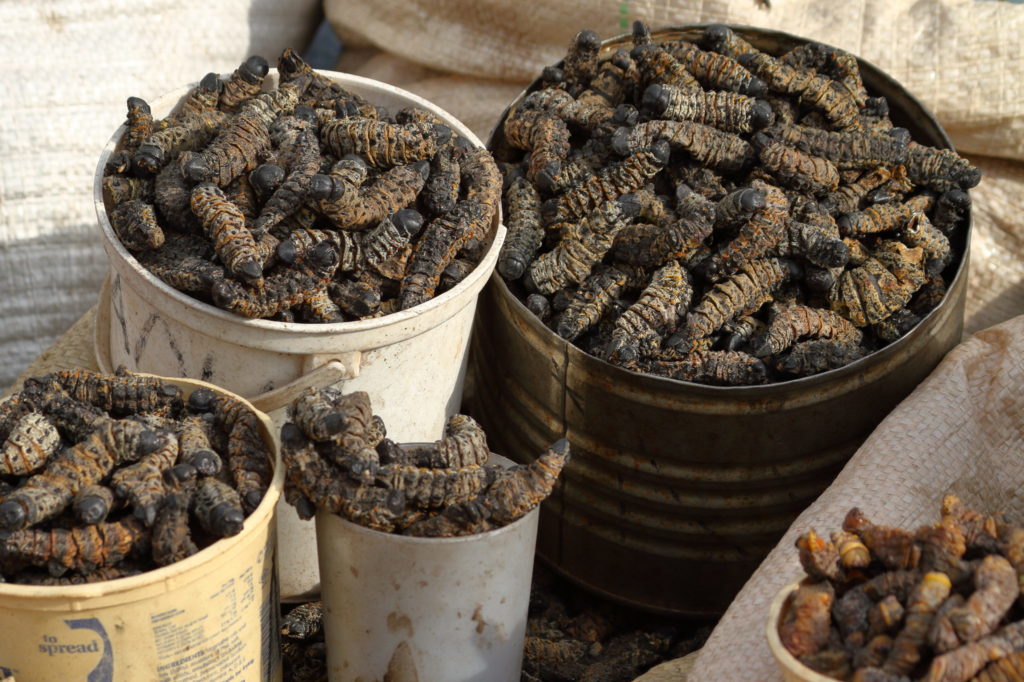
[{"xmin": 281, "ymin": 388, "xmax": 569, "ymax": 538}]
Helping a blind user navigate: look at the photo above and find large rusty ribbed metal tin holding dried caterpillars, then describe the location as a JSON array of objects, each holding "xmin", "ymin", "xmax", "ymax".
[{"xmin": 467, "ymin": 26, "xmax": 970, "ymax": 615}]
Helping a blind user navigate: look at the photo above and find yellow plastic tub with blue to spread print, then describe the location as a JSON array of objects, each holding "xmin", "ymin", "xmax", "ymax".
[{"xmin": 0, "ymin": 379, "xmax": 284, "ymax": 682}]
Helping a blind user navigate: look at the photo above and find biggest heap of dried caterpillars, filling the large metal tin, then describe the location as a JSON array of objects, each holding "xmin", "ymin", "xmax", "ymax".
[{"xmin": 495, "ymin": 22, "xmax": 980, "ymax": 385}]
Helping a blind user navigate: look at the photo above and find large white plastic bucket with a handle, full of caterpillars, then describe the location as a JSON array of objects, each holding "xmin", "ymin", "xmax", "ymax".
[{"xmin": 94, "ymin": 70, "xmax": 505, "ymax": 600}]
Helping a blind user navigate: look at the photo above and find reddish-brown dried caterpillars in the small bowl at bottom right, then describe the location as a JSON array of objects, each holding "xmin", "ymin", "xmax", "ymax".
[{"xmin": 778, "ymin": 495, "xmax": 1024, "ymax": 682}]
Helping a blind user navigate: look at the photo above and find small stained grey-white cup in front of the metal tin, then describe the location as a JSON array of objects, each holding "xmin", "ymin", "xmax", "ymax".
[{"xmin": 316, "ymin": 450, "xmax": 540, "ymax": 682}]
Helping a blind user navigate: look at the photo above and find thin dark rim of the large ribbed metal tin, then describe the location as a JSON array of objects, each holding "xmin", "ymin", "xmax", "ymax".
[{"xmin": 487, "ymin": 22, "xmax": 974, "ymax": 393}]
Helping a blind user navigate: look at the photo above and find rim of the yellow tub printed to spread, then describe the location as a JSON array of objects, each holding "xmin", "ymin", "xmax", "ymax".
[{"xmin": 0, "ymin": 372, "xmax": 285, "ymax": 610}]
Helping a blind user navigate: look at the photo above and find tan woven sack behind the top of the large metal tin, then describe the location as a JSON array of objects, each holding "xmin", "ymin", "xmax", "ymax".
[{"xmin": 325, "ymin": 0, "xmax": 1024, "ymax": 159}]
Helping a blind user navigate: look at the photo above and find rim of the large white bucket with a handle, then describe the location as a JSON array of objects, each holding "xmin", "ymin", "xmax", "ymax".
[{"xmin": 92, "ymin": 68, "xmax": 506, "ymax": 337}]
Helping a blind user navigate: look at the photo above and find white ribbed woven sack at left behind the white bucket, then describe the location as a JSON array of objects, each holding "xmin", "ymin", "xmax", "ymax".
[{"xmin": 0, "ymin": 0, "xmax": 319, "ymax": 386}]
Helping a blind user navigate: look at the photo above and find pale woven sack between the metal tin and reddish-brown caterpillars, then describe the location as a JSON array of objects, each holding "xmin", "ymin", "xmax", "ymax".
[{"xmin": 688, "ymin": 315, "xmax": 1024, "ymax": 682}]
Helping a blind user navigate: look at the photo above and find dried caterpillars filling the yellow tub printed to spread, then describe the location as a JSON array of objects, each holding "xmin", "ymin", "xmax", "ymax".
[{"xmin": 0, "ymin": 369, "xmax": 272, "ymax": 585}]
